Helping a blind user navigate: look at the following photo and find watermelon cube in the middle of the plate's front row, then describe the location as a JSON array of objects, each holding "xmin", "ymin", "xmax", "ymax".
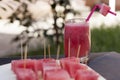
[{"xmin": 44, "ymin": 69, "xmax": 70, "ymax": 80}]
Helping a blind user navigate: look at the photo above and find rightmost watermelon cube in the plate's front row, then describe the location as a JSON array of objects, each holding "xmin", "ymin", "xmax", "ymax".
[{"xmin": 75, "ymin": 70, "xmax": 99, "ymax": 80}]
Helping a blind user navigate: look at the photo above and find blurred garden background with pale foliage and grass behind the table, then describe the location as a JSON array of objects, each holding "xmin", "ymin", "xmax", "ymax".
[{"xmin": 0, "ymin": 0, "xmax": 120, "ymax": 57}]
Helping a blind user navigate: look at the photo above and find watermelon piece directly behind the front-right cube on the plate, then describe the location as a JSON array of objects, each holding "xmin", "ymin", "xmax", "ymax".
[{"xmin": 66, "ymin": 62, "xmax": 88, "ymax": 78}]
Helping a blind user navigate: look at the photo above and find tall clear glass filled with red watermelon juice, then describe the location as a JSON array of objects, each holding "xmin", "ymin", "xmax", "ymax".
[{"xmin": 64, "ymin": 18, "xmax": 91, "ymax": 57}]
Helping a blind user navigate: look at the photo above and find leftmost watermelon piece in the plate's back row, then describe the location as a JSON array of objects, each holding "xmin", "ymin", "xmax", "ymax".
[{"xmin": 11, "ymin": 59, "xmax": 36, "ymax": 72}]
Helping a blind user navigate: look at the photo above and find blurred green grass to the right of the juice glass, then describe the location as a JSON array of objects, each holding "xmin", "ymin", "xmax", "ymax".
[{"xmin": 91, "ymin": 25, "xmax": 120, "ymax": 52}]
